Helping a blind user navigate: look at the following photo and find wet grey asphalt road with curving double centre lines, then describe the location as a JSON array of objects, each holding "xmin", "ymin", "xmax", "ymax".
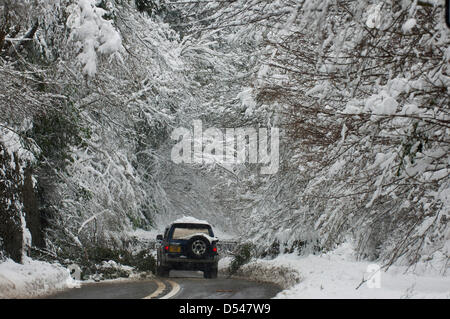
[{"xmin": 47, "ymin": 271, "xmax": 281, "ymax": 299}]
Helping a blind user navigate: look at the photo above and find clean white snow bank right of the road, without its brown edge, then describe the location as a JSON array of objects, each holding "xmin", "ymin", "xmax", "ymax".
[{"xmin": 272, "ymin": 244, "xmax": 450, "ymax": 299}]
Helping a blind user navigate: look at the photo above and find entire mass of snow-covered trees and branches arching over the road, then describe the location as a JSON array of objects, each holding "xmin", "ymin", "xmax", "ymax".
[{"xmin": 0, "ymin": 0, "xmax": 450, "ymax": 280}]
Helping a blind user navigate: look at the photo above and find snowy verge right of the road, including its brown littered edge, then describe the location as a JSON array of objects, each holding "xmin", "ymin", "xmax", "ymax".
[{"xmin": 219, "ymin": 244, "xmax": 450, "ymax": 299}]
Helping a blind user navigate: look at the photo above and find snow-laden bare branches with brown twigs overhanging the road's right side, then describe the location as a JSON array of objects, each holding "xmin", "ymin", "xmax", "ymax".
[{"xmin": 177, "ymin": 0, "xmax": 450, "ymax": 272}]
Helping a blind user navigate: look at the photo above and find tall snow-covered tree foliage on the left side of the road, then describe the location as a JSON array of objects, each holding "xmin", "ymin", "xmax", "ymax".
[{"xmin": 0, "ymin": 0, "xmax": 191, "ymax": 264}]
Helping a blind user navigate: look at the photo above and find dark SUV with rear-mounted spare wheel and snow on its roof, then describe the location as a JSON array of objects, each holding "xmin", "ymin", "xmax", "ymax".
[{"xmin": 156, "ymin": 222, "xmax": 219, "ymax": 278}]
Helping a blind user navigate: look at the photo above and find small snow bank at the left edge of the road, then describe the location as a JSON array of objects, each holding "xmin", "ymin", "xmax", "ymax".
[{"xmin": 0, "ymin": 258, "xmax": 75, "ymax": 299}]
